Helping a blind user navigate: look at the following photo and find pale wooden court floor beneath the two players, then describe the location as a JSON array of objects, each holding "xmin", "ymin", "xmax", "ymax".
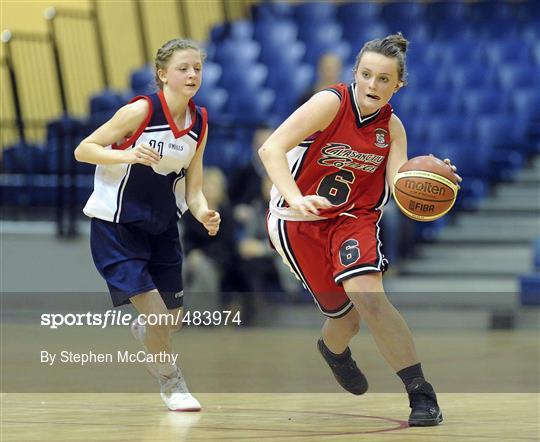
[{"xmin": 0, "ymin": 324, "xmax": 540, "ymax": 442}]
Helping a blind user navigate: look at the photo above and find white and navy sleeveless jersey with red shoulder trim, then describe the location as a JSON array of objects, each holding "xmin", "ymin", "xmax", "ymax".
[{"xmin": 84, "ymin": 91, "xmax": 207, "ymax": 233}]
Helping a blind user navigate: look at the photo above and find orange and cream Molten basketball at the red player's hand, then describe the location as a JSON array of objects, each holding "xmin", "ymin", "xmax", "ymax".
[{"xmin": 394, "ymin": 155, "xmax": 458, "ymax": 221}]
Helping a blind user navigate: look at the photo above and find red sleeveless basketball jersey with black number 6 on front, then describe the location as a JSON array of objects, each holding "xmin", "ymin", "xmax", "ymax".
[{"xmin": 270, "ymin": 83, "xmax": 392, "ymax": 220}]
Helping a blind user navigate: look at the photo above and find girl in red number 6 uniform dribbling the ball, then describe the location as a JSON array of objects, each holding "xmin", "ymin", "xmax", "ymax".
[{"xmin": 259, "ymin": 33, "xmax": 461, "ymax": 426}]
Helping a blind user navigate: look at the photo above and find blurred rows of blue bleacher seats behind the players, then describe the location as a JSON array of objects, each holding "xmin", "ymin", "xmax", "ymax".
[{"xmin": 3, "ymin": 0, "xmax": 540, "ymax": 266}]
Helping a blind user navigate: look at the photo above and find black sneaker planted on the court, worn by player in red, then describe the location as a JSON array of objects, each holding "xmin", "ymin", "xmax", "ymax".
[{"xmin": 407, "ymin": 378, "xmax": 443, "ymax": 427}]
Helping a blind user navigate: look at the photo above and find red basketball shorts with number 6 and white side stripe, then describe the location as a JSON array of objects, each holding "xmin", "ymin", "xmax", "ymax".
[{"xmin": 267, "ymin": 212, "xmax": 388, "ymax": 318}]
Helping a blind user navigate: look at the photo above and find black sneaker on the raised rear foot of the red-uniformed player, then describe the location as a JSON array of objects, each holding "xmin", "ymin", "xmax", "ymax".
[{"xmin": 317, "ymin": 338, "xmax": 368, "ymax": 394}]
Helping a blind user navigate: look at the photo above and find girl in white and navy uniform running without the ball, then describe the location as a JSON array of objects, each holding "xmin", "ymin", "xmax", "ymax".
[{"xmin": 75, "ymin": 39, "xmax": 220, "ymax": 411}]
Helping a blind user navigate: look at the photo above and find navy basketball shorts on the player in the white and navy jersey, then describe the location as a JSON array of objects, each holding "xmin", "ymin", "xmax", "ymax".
[{"xmin": 90, "ymin": 218, "xmax": 183, "ymax": 309}]
